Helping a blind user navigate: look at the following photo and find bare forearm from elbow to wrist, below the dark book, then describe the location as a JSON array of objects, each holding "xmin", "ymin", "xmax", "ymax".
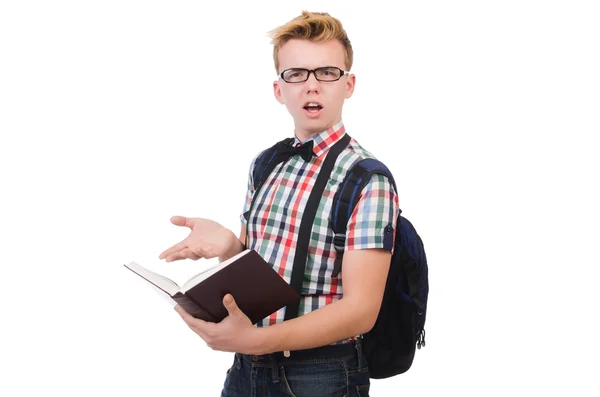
[{"xmin": 256, "ymin": 299, "xmax": 376, "ymax": 354}]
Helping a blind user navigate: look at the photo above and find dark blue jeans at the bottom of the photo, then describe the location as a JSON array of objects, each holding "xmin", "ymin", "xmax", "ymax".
[{"xmin": 221, "ymin": 339, "xmax": 370, "ymax": 397}]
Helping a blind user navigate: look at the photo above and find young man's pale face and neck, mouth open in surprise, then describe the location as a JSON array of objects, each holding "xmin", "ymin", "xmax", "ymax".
[{"xmin": 273, "ymin": 39, "xmax": 356, "ymax": 141}]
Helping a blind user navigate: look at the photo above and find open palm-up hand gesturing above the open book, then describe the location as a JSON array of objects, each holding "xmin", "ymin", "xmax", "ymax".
[{"xmin": 159, "ymin": 216, "xmax": 239, "ymax": 262}]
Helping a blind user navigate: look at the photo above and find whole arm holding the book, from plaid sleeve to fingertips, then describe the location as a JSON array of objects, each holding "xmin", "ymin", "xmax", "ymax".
[{"xmin": 175, "ymin": 177, "xmax": 399, "ymax": 354}]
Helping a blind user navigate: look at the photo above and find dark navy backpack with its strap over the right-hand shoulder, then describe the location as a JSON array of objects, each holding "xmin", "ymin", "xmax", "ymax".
[{"xmin": 330, "ymin": 159, "xmax": 429, "ymax": 379}]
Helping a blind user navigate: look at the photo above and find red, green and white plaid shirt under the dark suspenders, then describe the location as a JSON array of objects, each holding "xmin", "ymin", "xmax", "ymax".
[{"xmin": 241, "ymin": 121, "xmax": 399, "ymax": 327}]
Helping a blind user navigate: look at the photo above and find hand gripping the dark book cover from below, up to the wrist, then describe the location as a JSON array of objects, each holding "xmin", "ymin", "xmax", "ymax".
[{"xmin": 175, "ymin": 294, "xmax": 260, "ymax": 354}]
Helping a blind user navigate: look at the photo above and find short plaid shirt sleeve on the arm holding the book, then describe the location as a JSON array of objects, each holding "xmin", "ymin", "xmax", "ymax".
[{"xmin": 346, "ymin": 174, "xmax": 400, "ymax": 251}]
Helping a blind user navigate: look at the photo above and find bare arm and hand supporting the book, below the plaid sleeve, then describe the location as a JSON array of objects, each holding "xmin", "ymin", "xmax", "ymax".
[{"xmin": 175, "ymin": 249, "xmax": 391, "ymax": 354}]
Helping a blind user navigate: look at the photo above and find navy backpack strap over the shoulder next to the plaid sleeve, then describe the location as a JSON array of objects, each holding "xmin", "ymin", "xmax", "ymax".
[{"xmin": 329, "ymin": 158, "xmax": 397, "ymax": 277}]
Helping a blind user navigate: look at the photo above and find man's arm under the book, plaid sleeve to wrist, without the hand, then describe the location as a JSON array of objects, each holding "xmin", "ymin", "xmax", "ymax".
[{"xmin": 257, "ymin": 175, "xmax": 399, "ymax": 352}]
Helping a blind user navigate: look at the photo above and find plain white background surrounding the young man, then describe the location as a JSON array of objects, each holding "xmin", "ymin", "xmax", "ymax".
[{"xmin": 0, "ymin": 0, "xmax": 600, "ymax": 396}]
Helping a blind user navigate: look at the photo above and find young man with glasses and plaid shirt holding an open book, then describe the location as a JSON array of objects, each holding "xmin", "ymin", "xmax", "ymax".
[{"xmin": 160, "ymin": 12, "xmax": 399, "ymax": 397}]
